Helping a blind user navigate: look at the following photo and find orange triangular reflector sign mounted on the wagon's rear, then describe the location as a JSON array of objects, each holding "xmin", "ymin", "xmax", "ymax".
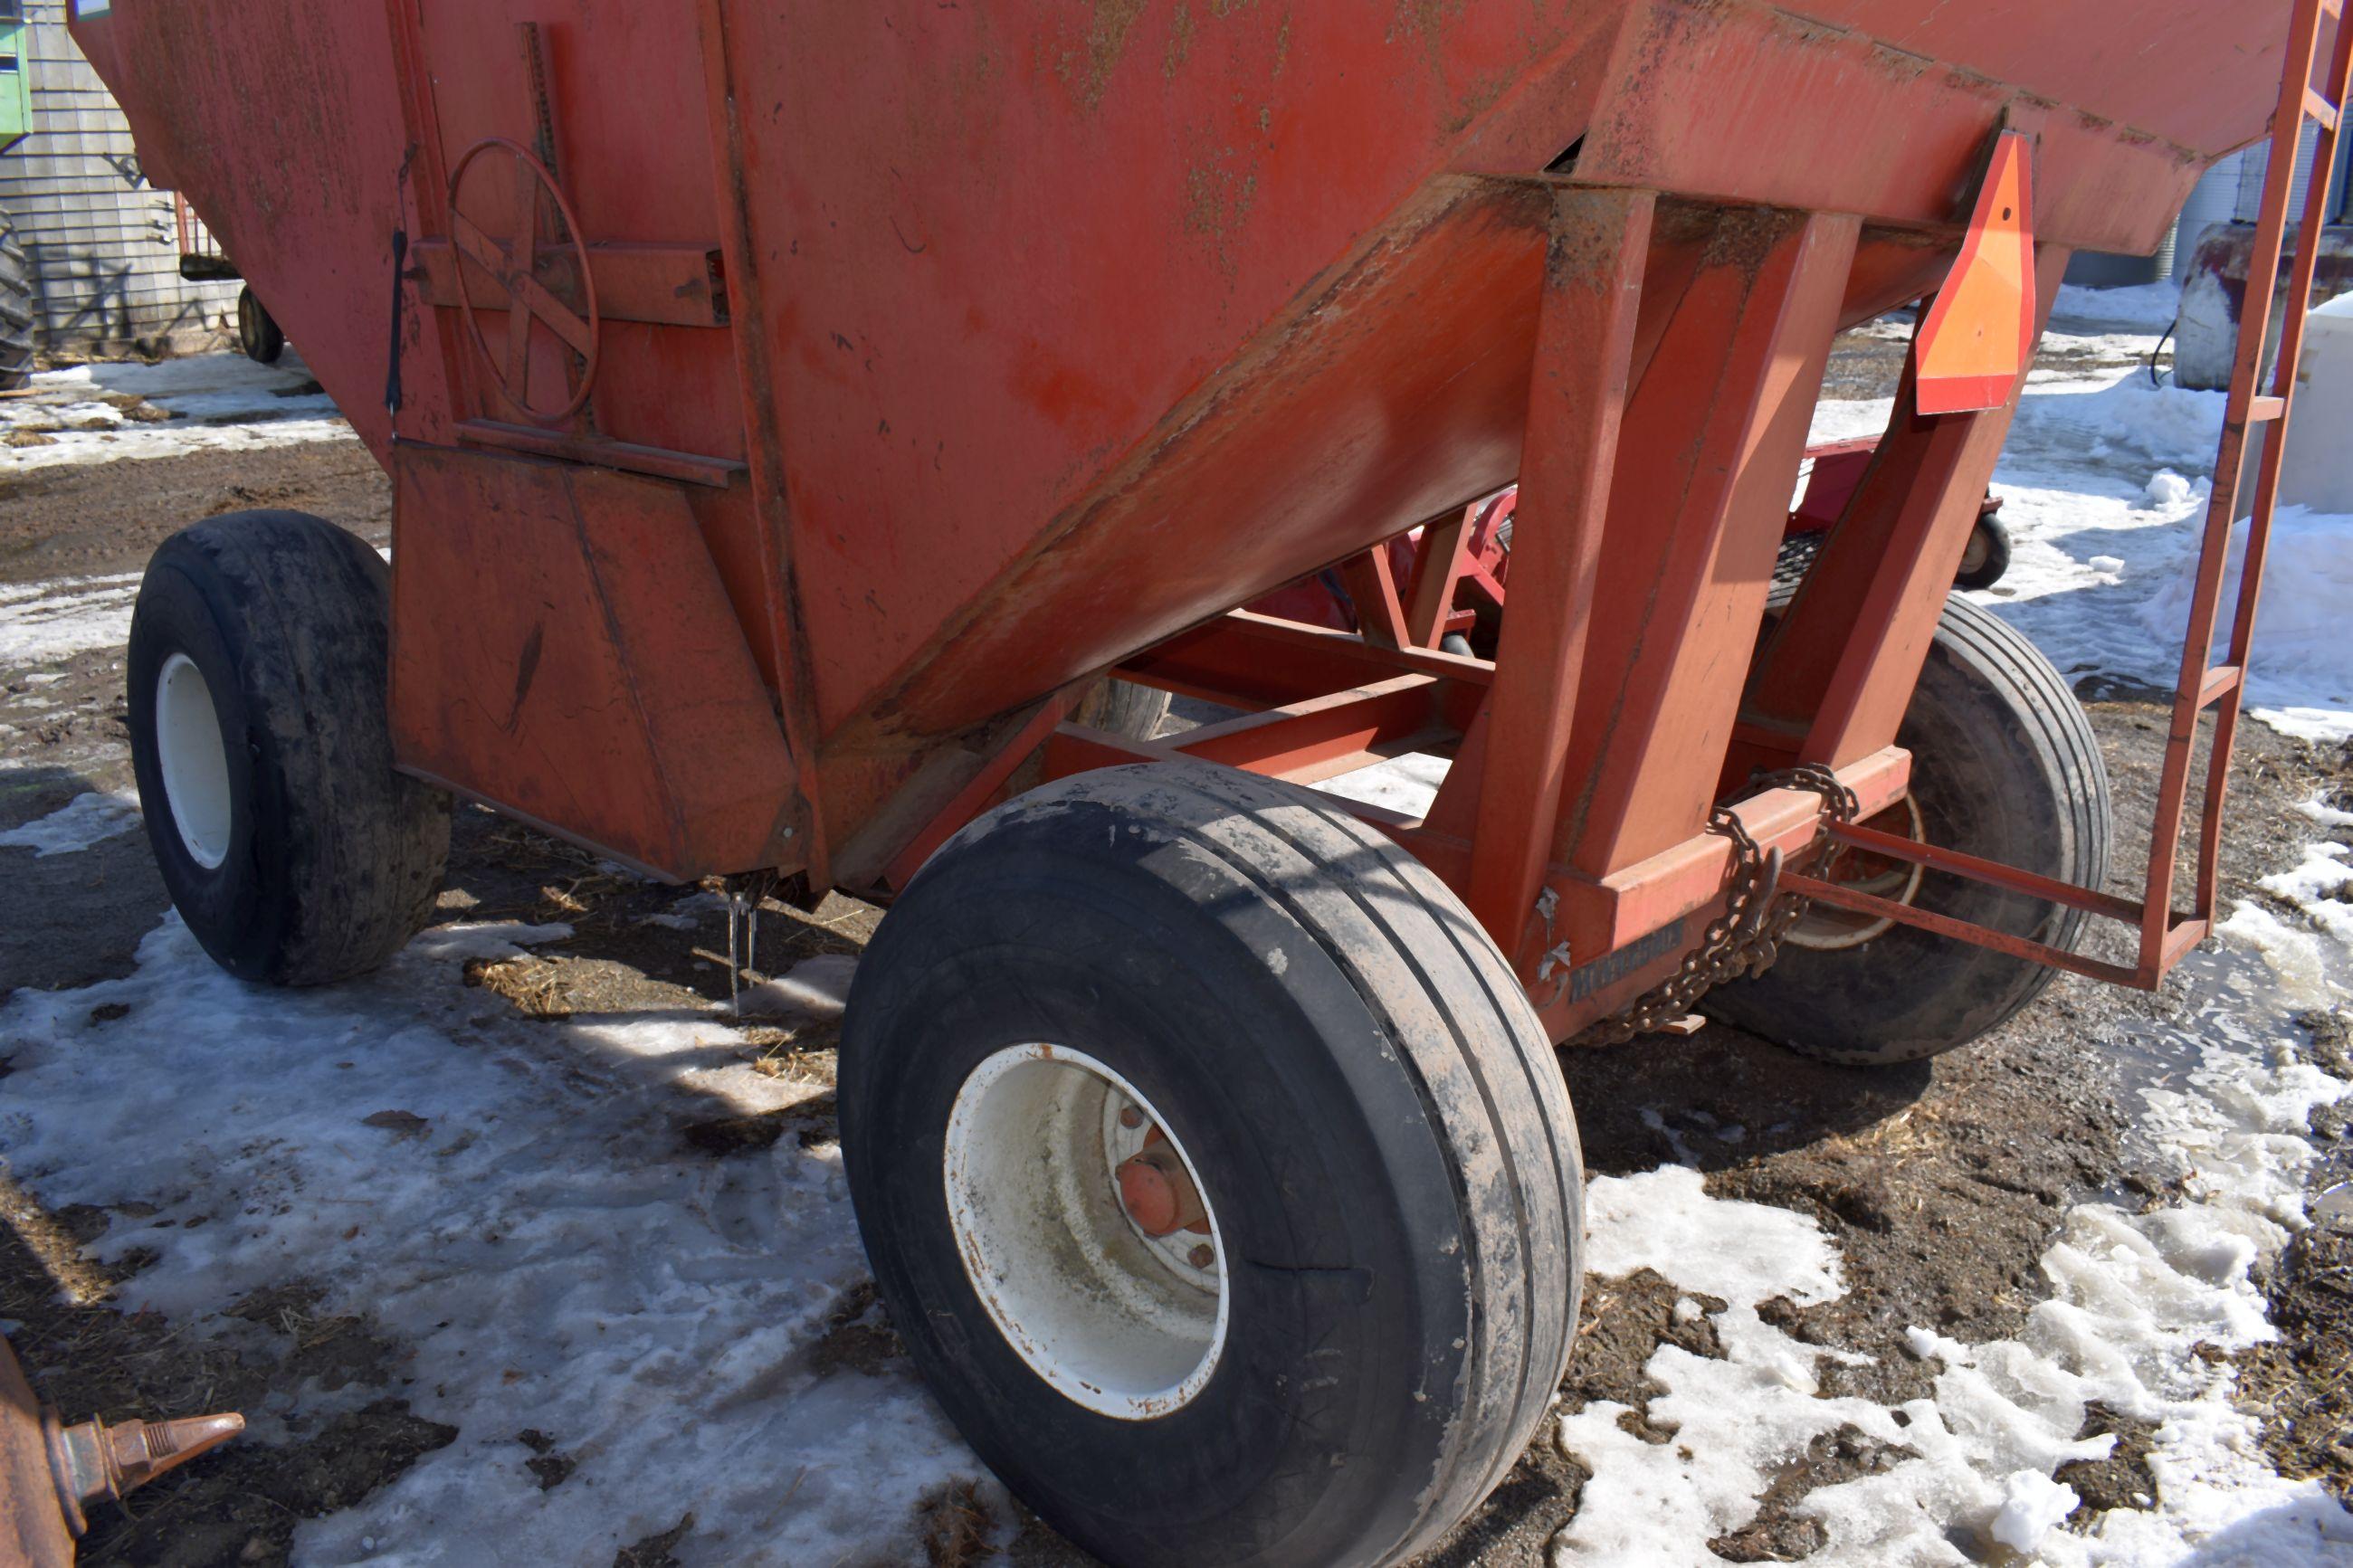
[{"xmin": 1918, "ymin": 131, "xmax": 2035, "ymax": 413}]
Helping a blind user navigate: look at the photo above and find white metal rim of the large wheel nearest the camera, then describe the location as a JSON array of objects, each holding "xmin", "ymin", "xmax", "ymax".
[{"xmin": 944, "ymin": 1046, "xmax": 1233, "ymax": 1420}]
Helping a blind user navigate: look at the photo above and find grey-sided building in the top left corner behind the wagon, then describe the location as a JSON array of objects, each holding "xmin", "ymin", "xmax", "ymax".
[{"xmin": 0, "ymin": 0, "xmax": 238, "ymax": 353}]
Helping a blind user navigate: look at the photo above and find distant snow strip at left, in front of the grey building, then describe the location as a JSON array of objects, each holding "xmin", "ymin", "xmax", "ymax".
[{"xmin": 0, "ymin": 350, "xmax": 350, "ymax": 472}]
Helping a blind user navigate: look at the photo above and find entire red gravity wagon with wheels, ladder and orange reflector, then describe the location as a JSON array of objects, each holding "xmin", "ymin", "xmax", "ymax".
[{"xmin": 73, "ymin": 0, "xmax": 2344, "ymax": 1568}]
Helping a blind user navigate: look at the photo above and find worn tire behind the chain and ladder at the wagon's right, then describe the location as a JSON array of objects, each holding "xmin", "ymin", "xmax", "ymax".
[{"xmin": 1701, "ymin": 590, "xmax": 2110, "ymax": 1068}]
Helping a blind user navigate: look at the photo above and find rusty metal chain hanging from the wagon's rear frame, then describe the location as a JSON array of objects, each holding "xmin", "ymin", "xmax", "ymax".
[{"xmin": 1593, "ymin": 762, "xmax": 1862, "ymax": 1046}]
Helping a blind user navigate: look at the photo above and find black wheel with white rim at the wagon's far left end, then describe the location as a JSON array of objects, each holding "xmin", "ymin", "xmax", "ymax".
[{"xmin": 125, "ymin": 512, "xmax": 450, "ymax": 985}]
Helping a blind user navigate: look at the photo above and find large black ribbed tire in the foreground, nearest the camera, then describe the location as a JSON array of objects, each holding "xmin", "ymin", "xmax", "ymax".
[{"xmin": 840, "ymin": 762, "xmax": 1584, "ymax": 1568}]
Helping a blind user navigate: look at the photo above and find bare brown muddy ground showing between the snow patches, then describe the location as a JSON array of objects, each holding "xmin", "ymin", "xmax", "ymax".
[{"xmin": 0, "ymin": 328, "xmax": 2353, "ymax": 1568}]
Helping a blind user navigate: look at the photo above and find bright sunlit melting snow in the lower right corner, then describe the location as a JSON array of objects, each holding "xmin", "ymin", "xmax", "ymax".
[{"xmin": 1553, "ymin": 1011, "xmax": 2353, "ymax": 1568}]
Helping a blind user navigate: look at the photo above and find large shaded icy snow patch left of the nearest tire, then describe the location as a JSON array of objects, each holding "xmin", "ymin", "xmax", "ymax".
[{"xmin": 0, "ymin": 917, "xmax": 986, "ymax": 1565}]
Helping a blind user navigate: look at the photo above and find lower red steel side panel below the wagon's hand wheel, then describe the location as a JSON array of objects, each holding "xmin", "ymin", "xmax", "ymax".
[{"xmin": 393, "ymin": 442, "xmax": 795, "ymax": 879}]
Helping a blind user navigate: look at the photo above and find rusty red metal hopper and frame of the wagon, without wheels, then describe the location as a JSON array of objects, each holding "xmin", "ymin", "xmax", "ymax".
[{"xmin": 75, "ymin": 0, "xmax": 2310, "ymax": 1034}]
